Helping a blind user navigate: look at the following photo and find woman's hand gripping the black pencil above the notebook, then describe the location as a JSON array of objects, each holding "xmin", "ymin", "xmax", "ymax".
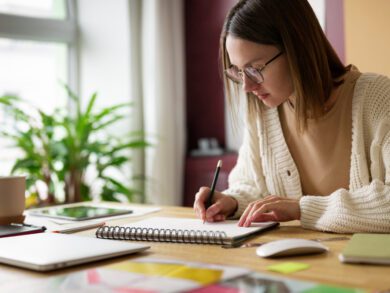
[{"xmin": 194, "ymin": 187, "xmax": 238, "ymax": 222}]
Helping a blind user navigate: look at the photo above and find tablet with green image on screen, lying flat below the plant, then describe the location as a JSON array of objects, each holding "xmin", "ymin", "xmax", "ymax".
[{"xmin": 29, "ymin": 205, "xmax": 133, "ymax": 221}]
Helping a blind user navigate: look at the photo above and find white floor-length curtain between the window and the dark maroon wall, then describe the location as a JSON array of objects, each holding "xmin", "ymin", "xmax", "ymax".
[{"xmin": 129, "ymin": 0, "xmax": 185, "ymax": 205}]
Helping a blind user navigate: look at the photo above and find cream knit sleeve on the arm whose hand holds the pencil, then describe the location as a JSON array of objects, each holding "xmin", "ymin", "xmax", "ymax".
[{"xmin": 223, "ymin": 113, "xmax": 266, "ymax": 218}]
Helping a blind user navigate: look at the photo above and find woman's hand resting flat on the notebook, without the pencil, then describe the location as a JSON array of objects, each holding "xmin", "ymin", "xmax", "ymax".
[{"xmin": 238, "ymin": 195, "xmax": 301, "ymax": 227}]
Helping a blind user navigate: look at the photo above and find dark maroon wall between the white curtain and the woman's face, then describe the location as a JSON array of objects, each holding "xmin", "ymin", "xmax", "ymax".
[{"xmin": 185, "ymin": 0, "xmax": 236, "ymax": 150}]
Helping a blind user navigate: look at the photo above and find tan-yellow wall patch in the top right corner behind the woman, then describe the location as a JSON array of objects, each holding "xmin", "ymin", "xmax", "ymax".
[{"xmin": 344, "ymin": 0, "xmax": 390, "ymax": 76}]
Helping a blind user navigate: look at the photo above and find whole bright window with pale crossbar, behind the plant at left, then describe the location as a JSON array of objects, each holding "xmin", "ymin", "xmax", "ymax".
[{"xmin": 0, "ymin": 0, "xmax": 77, "ymax": 175}]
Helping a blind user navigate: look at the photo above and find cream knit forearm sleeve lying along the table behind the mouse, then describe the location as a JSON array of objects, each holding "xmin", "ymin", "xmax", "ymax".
[{"xmin": 300, "ymin": 180, "xmax": 390, "ymax": 233}]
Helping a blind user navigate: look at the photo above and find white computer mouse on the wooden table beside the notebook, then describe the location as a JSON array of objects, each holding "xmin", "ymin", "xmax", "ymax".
[{"xmin": 256, "ymin": 238, "xmax": 329, "ymax": 257}]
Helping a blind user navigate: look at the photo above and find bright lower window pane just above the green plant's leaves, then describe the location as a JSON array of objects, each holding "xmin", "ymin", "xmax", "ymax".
[{"xmin": 0, "ymin": 39, "xmax": 67, "ymax": 112}]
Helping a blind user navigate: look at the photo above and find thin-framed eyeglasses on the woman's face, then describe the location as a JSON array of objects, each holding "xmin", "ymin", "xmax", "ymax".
[{"xmin": 224, "ymin": 52, "xmax": 283, "ymax": 84}]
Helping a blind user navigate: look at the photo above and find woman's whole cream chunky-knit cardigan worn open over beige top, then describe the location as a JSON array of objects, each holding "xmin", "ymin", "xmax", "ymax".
[{"xmin": 223, "ymin": 73, "xmax": 390, "ymax": 233}]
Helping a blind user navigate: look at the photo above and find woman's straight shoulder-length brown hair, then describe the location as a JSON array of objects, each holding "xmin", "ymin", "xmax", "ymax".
[{"xmin": 220, "ymin": 0, "xmax": 346, "ymax": 130}]
